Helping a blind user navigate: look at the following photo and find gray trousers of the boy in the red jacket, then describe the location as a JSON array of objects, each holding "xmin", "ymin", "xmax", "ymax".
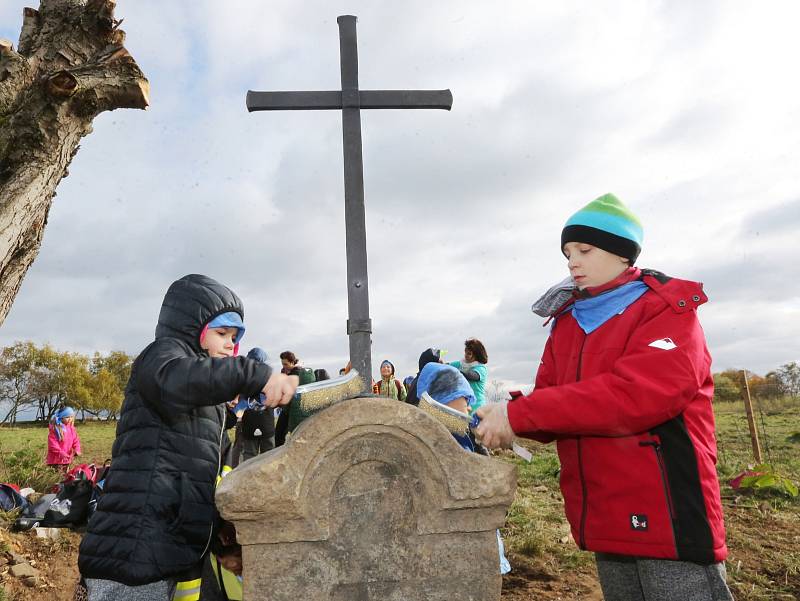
[{"xmin": 595, "ymin": 553, "xmax": 733, "ymax": 601}]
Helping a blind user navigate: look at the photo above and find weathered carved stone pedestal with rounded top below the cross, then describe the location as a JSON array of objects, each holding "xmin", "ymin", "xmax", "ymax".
[{"xmin": 217, "ymin": 398, "xmax": 516, "ymax": 601}]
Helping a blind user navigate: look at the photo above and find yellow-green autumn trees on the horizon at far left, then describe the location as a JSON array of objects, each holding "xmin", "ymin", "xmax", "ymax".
[{"xmin": 0, "ymin": 342, "xmax": 134, "ymax": 424}]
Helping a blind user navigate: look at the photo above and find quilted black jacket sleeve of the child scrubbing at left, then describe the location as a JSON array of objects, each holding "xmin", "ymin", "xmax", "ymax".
[{"xmin": 137, "ymin": 339, "xmax": 271, "ymax": 412}]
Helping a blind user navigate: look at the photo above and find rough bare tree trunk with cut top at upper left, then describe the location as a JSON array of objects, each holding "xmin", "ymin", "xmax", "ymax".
[{"xmin": 0, "ymin": 0, "xmax": 149, "ymax": 325}]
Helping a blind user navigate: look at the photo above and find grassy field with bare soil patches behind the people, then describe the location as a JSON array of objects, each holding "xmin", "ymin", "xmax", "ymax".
[{"xmin": 0, "ymin": 401, "xmax": 800, "ymax": 601}]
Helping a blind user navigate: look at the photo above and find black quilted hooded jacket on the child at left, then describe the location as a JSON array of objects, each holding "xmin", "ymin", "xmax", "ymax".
[{"xmin": 78, "ymin": 275, "xmax": 270, "ymax": 586}]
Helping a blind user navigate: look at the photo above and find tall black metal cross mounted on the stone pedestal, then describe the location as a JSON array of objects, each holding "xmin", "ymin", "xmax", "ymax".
[{"xmin": 247, "ymin": 15, "xmax": 453, "ymax": 380}]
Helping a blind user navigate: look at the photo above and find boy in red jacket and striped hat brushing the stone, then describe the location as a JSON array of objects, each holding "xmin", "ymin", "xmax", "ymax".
[{"xmin": 477, "ymin": 194, "xmax": 732, "ymax": 601}]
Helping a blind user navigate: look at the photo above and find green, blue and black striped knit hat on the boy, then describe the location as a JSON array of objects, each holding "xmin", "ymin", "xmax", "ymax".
[{"xmin": 561, "ymin": 194, "xmax": 644, "ymax": 265}]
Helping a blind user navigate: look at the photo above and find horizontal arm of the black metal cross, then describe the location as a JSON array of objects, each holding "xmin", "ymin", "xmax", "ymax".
[{"xmin": 247, "ymin": 90, "xmax": 453, "ymax": 113}]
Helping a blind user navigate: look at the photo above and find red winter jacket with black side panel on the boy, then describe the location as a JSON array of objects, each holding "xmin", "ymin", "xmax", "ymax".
[{"xmin": 508, "ymin": 269, "xmax": 728, "ymax": 564}]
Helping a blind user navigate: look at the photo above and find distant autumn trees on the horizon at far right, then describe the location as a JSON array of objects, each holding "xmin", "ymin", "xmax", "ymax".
[{"xmin": 714, "ymin": 361, "xmax": 800, "ymax": 401}]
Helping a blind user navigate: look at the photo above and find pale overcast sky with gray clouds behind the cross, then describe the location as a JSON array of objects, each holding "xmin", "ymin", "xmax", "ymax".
[{"xmin": 0, "ymin": 0, "xmax": 800, "ymax": 386}]
